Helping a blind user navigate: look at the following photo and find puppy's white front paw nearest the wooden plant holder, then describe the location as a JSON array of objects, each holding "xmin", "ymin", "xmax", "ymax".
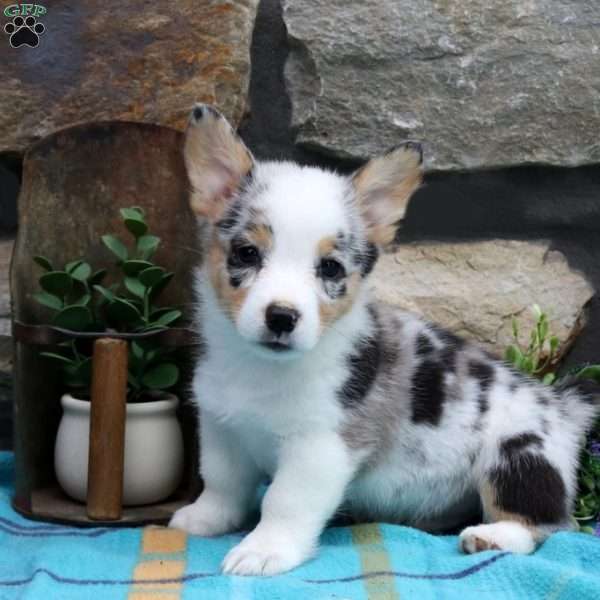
[{"xmin": 169, "ymin": 493, "xmax": 244, "ymax": 537}]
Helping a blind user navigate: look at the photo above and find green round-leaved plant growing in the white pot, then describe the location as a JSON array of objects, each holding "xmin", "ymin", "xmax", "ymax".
[{"xmin": 34, "ymin": 207, "xmax": 181, "ymax": 402}]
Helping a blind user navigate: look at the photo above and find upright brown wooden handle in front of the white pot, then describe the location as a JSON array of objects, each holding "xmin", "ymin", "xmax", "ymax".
[{"xmin": 87, "ymin": 338, "xmax": 127, "ymax": 520}]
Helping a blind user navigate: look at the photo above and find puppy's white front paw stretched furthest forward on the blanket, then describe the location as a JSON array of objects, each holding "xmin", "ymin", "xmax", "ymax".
[{"xmin": 221, "ymin": 526, "xmax": 313, "ymax": 575}]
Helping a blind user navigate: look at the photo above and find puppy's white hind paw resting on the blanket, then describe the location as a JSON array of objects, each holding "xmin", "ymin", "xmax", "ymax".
[{"xmin": 459, "ymin": 521, "xmax": 536, "ymax": 554}]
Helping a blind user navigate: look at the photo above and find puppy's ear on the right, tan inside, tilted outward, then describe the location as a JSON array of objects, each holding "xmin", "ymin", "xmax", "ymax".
[{"xmin": 352, "ymin": 142, "xmax": 423, "ymax": 246}]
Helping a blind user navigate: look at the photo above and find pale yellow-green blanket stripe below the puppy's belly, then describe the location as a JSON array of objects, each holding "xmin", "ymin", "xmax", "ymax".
[{"xmin": 351, "ymin": 523, "xmax": 400, "ymax": 600}]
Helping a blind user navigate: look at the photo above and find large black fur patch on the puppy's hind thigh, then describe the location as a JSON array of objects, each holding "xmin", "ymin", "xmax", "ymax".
[{"xmin": 489, "ymin": 454, "xmax": 567, "ymax": 525}]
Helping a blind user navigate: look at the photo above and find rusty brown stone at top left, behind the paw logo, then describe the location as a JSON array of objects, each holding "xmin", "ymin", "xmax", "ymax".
[{"xmin": 0, "ymin": 0, "xmax": 258, "ymax": 152}]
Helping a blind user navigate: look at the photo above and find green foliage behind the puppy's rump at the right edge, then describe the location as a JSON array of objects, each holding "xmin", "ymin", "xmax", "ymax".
[{"xmin": 504, "ymin": 304, "xmax": 600, "ymax": 532}]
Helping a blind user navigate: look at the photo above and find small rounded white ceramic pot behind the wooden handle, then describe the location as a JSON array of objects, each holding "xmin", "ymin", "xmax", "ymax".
[{"xmin": 54, "ymin": 394, "xmax": 183, "ymax": 506}]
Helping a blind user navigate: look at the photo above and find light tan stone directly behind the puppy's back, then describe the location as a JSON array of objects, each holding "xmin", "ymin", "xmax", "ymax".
[{"xmin": 373, "ymin": 240, "xmax": 593, "ymax": 355}]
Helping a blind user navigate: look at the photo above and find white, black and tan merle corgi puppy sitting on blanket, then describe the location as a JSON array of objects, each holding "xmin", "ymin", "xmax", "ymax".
[{"xmin": 170, "ymin": 105, "xmax": 598, "ymax": 575}]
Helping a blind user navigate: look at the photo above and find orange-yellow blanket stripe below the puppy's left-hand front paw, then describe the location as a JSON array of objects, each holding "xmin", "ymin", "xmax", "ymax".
[{"xmin": 128, "ymin": 527, "xmax": 187, "ymax": 600}]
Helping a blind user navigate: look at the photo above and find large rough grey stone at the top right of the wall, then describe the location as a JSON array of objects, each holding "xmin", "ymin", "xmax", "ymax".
[{"xmin": 284, "ymin": 0, "xmax": 600, "ymax": 169}]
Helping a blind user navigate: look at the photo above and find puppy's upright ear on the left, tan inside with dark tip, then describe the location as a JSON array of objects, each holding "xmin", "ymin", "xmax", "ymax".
[{"xmin": 183, "ymin": 104, "xmax": 254, "ymax": 222}]
